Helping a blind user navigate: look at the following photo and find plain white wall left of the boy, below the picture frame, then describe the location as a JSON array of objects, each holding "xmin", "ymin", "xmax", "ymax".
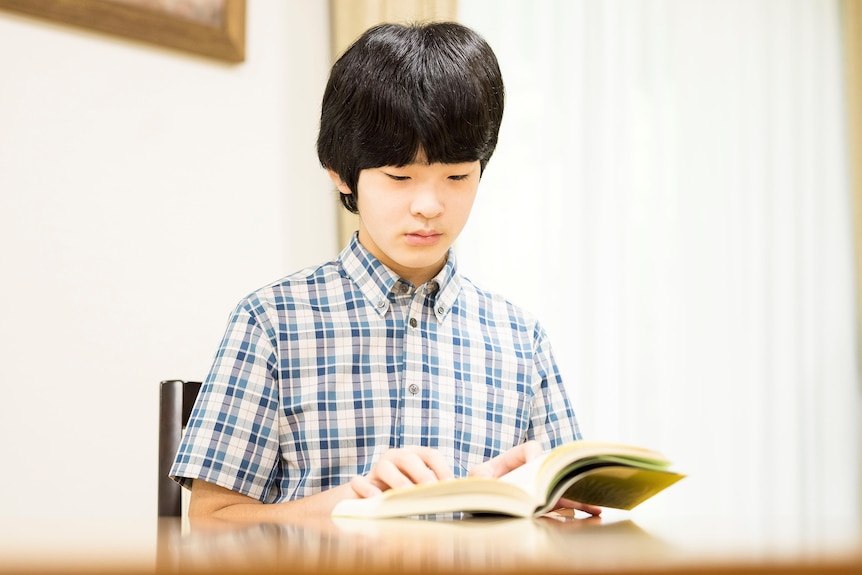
[{"xmin": 0, "ymin": 0, "xmax": 338, "ymax": 517}]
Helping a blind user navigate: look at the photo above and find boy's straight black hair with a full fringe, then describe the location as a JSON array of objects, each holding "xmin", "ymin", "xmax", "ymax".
[{"xmin": 317, "ymin": 22, "xmax": 504, "ymax": 213}]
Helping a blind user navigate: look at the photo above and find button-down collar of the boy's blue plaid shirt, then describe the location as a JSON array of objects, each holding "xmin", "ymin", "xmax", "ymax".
[{"xmin": 338, "ymin": 234, "xmax": 461, "ymax": 322}]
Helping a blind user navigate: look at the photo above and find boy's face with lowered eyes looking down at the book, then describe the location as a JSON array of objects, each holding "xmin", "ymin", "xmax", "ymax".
[{"xmin": 331, "ymin": 158, "xmax": 481, "ymax": 286}]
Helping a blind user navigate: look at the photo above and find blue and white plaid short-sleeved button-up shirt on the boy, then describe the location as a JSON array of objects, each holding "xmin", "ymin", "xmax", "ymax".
[{"xmin": 171, "ymin": 236, "xmax": 580, "ymax": 503}]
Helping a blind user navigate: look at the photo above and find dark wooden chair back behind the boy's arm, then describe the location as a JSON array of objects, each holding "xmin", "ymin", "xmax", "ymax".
[{"xmin": 159, "ymin": 379, "xmax": 201, "ymax": 517}]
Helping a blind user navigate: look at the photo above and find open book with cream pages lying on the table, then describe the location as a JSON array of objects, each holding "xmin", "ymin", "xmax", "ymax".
[{"xmin": 332, "ymin": 441, "xmax": 685, "ymax": 518}]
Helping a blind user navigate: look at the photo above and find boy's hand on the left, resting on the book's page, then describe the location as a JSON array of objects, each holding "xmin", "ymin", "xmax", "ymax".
[{"xmin": 350, "ymin": 446, "xmax": 454, "ymax": 498}]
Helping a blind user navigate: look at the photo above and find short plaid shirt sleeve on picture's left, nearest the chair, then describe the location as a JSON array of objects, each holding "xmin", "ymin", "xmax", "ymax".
[{"xmin": 170, "ymin": 303, "xmax": 279, "ymax": 503}]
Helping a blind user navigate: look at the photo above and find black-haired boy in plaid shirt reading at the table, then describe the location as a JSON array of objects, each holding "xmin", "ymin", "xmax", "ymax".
[{"xmin": 171, "ymin": 23, "xmax": 599, "ymax": 521}]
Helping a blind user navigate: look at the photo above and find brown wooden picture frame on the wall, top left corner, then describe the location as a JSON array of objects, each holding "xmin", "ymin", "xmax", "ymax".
[{"xmin": 0, "ymin": 0, "xmax": 246, "ymax": 63}]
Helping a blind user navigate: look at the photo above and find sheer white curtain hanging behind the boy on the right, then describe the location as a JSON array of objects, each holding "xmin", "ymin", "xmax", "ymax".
[{"xmin": 458, "ymin": 0, "xmax": 860, "ymax": 530}]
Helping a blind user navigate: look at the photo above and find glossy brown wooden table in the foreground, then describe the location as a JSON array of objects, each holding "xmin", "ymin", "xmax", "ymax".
[{"xmin": 0, "ymin": 514, "xmax": 862, "ymax": 575}]
